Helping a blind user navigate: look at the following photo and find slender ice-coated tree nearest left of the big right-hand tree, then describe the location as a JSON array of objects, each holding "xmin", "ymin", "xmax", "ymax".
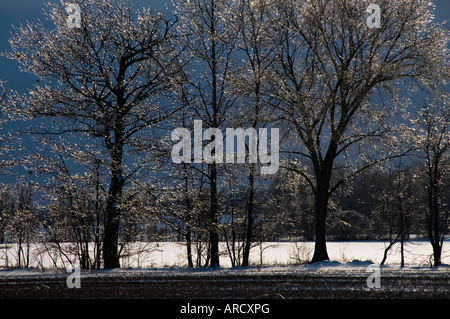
[{"xmin": 230, "ymin": 0, "xmax": 282, "ymax": 266}]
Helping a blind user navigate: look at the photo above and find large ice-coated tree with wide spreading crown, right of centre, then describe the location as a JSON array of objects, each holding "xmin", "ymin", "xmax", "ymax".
[{"xmin": 268, "ymin": 0, "xmax": 449, "ymax": 262}]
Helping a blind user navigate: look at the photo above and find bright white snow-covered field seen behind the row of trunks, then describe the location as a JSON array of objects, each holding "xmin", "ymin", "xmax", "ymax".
[{"xmin": 0, "ymin": 239, "xmax": 450, "ymax": 269}]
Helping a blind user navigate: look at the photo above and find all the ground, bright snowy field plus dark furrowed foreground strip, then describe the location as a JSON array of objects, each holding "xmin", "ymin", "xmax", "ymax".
[{"xmin": 0, "ymin": 240, "xmax": 450, "ymax": 300}]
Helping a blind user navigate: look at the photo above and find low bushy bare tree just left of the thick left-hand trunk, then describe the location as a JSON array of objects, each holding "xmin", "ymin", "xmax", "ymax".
[{"xmin": 22, "ymin": 136, "xmax": 107, "ymax": 269}]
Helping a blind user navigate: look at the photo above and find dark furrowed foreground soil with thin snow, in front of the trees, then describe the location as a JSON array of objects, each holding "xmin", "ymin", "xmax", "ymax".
[{"xmin": 0, "ymin": 261, "xmax": 450, "ymax": 300}]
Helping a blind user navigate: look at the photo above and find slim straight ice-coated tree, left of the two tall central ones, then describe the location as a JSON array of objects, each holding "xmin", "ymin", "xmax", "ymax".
[{"xmin": 174, "ymin": 0, "xmax": 241, "ymax": 266}]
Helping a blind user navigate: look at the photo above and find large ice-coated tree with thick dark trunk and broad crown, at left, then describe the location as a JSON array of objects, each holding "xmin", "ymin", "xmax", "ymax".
[{"xmin": 7, "ymin": 0, "xmax": 178, "ymax": 268}]
